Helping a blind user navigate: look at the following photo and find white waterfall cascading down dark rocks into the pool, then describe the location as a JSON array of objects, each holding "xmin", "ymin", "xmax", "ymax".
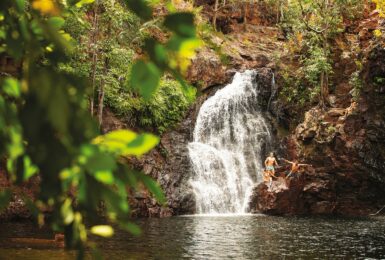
[{"xmin": 188, "ymin": 70, "xmax": 271, "ymax": 214}]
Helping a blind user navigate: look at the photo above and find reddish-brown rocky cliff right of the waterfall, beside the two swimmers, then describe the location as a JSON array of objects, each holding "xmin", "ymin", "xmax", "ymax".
[{"xmin": 250, "ymin": 8, "xmax": 385, "ymax": 215}]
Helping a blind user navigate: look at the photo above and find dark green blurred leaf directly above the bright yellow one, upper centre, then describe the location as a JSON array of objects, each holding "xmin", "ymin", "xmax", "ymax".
[{"xmin": 164, "ymin": 12, "xmax": 195, "ymax": 38}]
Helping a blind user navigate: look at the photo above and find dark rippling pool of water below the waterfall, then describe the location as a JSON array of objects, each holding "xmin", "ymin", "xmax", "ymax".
[{"xmin": 0, "ymin": 215, "xmax": 385, "ymax": 260}]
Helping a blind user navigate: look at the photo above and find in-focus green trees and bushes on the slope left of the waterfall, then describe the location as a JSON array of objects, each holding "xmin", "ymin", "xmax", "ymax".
[{"xmin": 62, "ymin": 0, "xmax": 195, "ymax": 133}]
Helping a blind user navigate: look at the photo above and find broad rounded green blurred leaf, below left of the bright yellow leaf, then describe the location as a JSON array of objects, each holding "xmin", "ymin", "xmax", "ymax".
[{"xmin": 131, "ymin": 60, "xmax": 161, "ymax": 100}]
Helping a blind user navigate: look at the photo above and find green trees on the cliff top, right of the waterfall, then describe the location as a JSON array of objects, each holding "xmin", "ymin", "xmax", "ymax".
[{"xmin": 281, "ymin": 0, "xmax": 364, "ymax": 107}]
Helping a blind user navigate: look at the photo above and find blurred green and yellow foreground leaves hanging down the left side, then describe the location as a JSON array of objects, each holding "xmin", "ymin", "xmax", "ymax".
[{"xmin": 0, "ymin": 0, "xmax": 199, "ymax": 256}]
